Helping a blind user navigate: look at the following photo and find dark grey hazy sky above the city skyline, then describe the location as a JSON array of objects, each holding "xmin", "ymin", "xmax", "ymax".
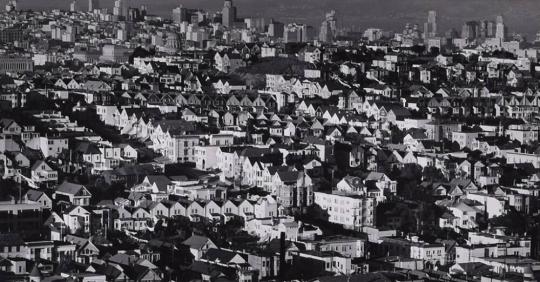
[{"xmin": 11, "ymin": 0, "xmax": 540, "ymax": 39}]
